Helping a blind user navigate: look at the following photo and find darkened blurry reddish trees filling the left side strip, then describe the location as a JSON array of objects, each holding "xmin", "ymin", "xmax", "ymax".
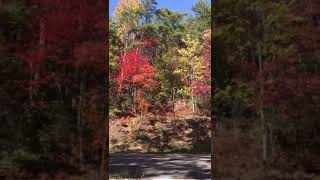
[{"xmin": 0, "ymin": 0, "xmax": 108, "ymax": 179}]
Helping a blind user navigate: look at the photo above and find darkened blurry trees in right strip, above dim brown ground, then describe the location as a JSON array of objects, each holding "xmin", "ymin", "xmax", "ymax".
[{"xmin": 212, "ymin": 0, "xmax": 320, "ymax": 177}]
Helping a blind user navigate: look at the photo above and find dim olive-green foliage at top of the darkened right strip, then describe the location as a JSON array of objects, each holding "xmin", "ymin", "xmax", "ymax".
[{"xmin": 213, "ymin": 0, "xmax": 299, "ymax": 64}]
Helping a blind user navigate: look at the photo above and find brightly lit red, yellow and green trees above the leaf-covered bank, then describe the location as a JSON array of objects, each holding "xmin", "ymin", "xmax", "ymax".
[{"xmin": 109, "ymin": 0, "xmax": 211, "ymax": 117}]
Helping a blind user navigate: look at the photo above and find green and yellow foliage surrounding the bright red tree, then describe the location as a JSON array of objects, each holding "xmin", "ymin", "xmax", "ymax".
[{"xmin": 109, "ymin": 0, "xmax": 211, "ymax": 115}]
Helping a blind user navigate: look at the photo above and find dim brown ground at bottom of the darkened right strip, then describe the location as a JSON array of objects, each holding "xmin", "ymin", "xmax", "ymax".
[{"xmin": 213, "ymin": 125, "xmax": 320, "ymax": 180}]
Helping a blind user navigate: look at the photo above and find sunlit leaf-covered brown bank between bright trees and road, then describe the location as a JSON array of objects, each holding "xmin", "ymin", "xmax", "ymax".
[{"xmin": 109, "ymin": 116, "xmax": 210, "ymax": 153}]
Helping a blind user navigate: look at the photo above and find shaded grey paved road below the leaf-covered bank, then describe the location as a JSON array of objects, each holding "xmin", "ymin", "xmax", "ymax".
[{"xmin": 109, "ymin": 153, "xmax": 211, "ymax": 179}]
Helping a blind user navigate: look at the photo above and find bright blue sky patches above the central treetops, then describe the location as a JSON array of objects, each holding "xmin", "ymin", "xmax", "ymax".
[{"xmin": 109, "ymin": 0, "xmax": 201, "ymax": 16}]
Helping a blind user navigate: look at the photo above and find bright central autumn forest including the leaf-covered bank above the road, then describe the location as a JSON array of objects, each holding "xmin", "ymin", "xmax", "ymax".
[{"xmin": 109, "ymin": 0, "xmax": 211, "ymax": 155}]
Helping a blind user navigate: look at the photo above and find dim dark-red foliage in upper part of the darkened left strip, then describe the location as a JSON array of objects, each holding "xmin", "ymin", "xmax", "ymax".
[{"xmin": 17, "ymin": 0, "xmax": 106, "ymax": 111}]
